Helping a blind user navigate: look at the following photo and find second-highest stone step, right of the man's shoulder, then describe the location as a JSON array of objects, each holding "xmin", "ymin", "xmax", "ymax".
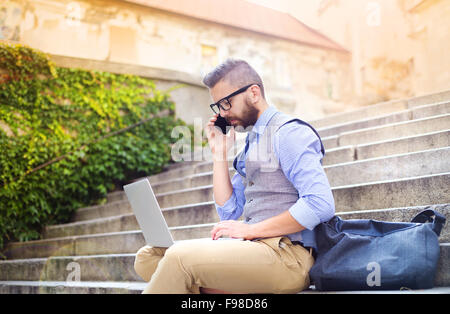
[{"xmin": 317, "ymin": 101, "xmax": 450, "ymax": 138}]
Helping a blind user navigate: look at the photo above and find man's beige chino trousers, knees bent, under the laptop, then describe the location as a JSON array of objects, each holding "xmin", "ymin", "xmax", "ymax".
[{"xmin": 134, "ymin": 237, "xmax": 314, "ymax": 294}]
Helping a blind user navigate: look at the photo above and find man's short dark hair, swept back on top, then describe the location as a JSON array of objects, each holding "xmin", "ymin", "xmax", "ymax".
[{"xmin": 203, "ymin": 59, "xmax": 266, "ymax": 99}]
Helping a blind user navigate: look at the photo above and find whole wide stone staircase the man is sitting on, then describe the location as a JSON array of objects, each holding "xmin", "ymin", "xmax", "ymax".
[{"xmin": 0, "ymin": 91, "xmax": 450, "ymax": 293}]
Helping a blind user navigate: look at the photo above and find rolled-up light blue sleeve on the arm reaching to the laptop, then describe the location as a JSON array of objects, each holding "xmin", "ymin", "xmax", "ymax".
[{"xmin": 274, "ymin": 122, "xmax": 335, "ymax": 230}]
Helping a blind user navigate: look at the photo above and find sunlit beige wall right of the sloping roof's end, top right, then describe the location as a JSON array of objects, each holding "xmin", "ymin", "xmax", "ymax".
[{"xmin": 302, "ymin": 0, "xmax": 450, "ymax": 103}]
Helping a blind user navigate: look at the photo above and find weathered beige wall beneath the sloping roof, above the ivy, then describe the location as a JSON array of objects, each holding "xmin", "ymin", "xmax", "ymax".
[{"xmin": 0, "ymin": 0, "xmax": 353, "ymax": 122}]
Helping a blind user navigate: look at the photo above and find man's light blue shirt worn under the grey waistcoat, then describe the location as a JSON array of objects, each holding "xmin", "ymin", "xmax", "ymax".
[{"xmin": 215, "ymin": 106, "xmax": 335, "ymax": 247}]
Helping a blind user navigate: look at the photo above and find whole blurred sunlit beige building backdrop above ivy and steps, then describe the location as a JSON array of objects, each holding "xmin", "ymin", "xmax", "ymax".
[{"xmin": 0, "ymin": 0, "xmax": 450, "ymax": 122}]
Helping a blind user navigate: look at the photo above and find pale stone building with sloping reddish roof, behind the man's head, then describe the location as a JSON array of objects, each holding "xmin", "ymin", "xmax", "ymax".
[{"xmin": 0, "ymin": 0, "xmax": 353, "ymax": 123}]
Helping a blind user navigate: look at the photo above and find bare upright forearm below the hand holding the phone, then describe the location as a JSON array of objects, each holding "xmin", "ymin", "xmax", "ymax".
[{"xmin": 213, "ymin": 158, "xmax": 233, "ymax": 206}]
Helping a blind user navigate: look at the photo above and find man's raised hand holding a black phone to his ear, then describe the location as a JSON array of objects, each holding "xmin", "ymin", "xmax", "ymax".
[{"xmin": 205, "ymin": 114, "xmax": 236, "ymax": 161}]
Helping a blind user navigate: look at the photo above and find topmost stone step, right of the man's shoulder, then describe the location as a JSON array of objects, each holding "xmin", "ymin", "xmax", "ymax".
[{"xmin": 310, "ymin": 91, "xmax": 450, "ymax": 129}]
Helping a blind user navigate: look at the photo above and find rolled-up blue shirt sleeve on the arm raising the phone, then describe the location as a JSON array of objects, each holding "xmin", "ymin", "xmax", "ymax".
[{"xmin": 213, "ymin": 173, "xmax": 245, "ymax": 220}]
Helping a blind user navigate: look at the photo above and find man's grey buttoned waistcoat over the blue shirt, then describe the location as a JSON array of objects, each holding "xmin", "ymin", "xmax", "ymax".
[{"xmin": 234, "ymin": 112, "xmax": 325, "ymax": 241}]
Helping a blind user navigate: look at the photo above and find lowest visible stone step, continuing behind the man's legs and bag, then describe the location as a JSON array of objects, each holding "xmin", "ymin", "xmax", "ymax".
[{"xmin": 0, "ymin": 243, "xmax": 450, "ymax": 293}]
